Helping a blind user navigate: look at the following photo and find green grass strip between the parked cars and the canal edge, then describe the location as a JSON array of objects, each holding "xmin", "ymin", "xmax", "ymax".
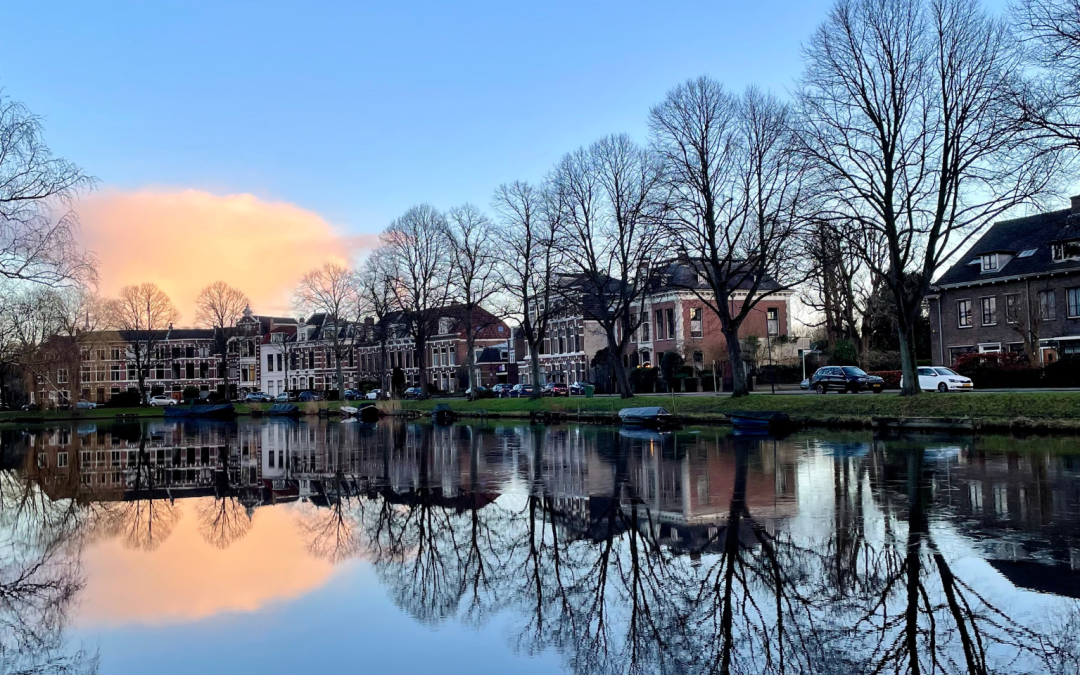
[{"xmin": 404, "ymin": 392, "xmax": 1080, "ymax": 422}]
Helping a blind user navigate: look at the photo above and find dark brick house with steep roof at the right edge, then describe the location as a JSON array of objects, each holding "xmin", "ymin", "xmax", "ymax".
[{"xmin": 928, "ymin": 197, "xmax": 1080, "ymax": 365}]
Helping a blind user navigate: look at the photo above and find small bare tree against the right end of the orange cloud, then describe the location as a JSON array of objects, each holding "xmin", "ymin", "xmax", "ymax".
[{"xmin": 296, "ymin": 262, "xmax": 357, "ymax": 401}]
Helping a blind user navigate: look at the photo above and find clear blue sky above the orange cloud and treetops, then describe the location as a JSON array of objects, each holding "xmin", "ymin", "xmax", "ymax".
[{"xmin": 0, "ymin": 0, "xmax": 1000, "ymax": 232}]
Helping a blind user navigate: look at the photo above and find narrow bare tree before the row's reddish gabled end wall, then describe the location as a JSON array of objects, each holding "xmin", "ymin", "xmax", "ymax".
[{"xmin": 447, "ymin": 204, "xmax": 509, "ymax": 391}]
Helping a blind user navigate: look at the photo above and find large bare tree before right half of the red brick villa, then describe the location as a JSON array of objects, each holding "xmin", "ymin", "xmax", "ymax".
[{"xmin": 649, "ymin": 77, "xmax": 807, "ymax": 396}]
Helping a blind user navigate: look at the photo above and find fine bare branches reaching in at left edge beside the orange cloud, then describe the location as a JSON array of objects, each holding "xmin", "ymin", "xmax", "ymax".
[{"xmin": 0, "ymin": 93, "xmax": 96, "ymax": 286}]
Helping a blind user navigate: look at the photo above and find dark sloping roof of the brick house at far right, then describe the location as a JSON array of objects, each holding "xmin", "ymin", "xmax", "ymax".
[{"xmin": 934, "ymin": 208, "xmax": 1080, "ymax": 286}]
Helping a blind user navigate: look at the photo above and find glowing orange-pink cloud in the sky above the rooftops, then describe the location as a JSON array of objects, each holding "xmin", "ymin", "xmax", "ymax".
[{"xmin": 79, "ymin": 190, "xmax": 377, "ymax": 317}]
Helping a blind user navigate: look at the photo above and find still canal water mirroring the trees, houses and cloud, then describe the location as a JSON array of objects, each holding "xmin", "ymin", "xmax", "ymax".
[{"xmin": 0, "ymin": 419, "xmax": 1080, "ymax": 675}]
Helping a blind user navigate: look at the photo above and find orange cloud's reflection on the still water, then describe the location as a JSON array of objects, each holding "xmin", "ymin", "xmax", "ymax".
[{"xmin": 79, "ymin": 498, "xmax": 333, "ymax": 626}]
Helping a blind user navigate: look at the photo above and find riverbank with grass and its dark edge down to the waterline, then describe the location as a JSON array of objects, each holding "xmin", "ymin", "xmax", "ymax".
[{"xmin": 394, "ymin": 392, "xmax": 1080, "ymax": 433}]
